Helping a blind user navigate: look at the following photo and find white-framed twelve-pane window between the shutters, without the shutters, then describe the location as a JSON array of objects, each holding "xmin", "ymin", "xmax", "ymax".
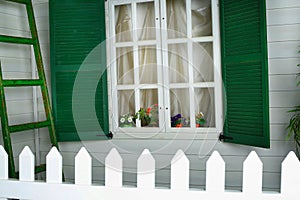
[{"xmin": 108, "ymin": 0, "xmax": 222, "ymax": 132}]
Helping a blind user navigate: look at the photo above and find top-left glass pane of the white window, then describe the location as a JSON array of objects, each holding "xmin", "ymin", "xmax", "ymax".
[{"xmin": 115, "ymin": 4, "xmax": 132, "ymax": 42}]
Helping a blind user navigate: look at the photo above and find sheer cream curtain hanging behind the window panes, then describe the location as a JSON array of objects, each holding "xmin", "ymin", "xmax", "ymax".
[{"xmin": 116, "ymin": 0, "xmax": 214, "ymax": 126}]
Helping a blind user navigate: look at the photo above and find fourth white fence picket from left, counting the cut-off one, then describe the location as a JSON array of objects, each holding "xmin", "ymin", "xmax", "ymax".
[{"xmin": 75, "ymin": 147, "xmax": 92, "ymax": 185}]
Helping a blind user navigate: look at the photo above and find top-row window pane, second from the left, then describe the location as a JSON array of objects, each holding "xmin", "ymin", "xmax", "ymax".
[{"xmin": 137, "ymin": 2, "xmax": 156, "ymax": 40}]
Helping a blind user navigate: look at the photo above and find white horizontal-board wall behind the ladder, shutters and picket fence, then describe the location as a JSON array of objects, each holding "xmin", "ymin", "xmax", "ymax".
[{"xmin": 0, "ymin": 0, "xmax": 300, "ymax": 190}]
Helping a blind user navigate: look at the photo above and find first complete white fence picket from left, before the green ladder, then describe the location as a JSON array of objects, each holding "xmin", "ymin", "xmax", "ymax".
[{"xmin": 19, "ymin": 146, "xmax": 35, "ymax": 181}]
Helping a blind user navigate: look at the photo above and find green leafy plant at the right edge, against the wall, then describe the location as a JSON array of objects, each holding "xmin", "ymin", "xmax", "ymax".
[{"xmin": 287, "ymin": 51, "xmax": 300, "ymax": 159}]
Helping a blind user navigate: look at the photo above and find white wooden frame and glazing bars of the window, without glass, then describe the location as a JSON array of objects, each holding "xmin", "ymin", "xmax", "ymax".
[{"xmin": 108, "ymin": 0, "xmax": 223, "ymax": 136}]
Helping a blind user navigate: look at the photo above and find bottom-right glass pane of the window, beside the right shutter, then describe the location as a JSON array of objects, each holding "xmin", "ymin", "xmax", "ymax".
[{"xmin": 194, "ymin": 88, "xmax": 215, "ymax": 127}]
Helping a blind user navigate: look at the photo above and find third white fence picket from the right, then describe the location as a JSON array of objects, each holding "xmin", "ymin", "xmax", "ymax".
[{"xmin": 206, "ymin": 151, "xmax": 225, "ymax": 192}]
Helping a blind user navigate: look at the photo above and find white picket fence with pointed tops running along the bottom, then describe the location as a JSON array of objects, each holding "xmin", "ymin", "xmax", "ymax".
[{"xmin": 0, "ymin": 146, "xmax": 300, "ymax": 200}]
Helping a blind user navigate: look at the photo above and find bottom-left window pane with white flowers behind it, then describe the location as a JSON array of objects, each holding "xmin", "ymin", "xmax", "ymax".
[{"xmin": 118, "ymin": 90, "xmax": 135, "ymax": 127}]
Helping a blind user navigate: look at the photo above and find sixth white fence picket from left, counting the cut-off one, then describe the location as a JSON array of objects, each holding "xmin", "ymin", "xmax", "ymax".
[{"xmin": 137, "ymin": 149, "xmax": 155, "ymax": 189}]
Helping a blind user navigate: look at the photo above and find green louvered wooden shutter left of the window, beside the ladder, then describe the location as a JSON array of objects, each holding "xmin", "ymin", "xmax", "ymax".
[{"xmin": 49, "ymin": 0, "xmax": 109, "ymax": 141}]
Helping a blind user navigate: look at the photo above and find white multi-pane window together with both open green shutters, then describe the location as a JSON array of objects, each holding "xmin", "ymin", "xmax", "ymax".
[{"xmin": 49, "ymin": 0, "xmax": 270, "ymax": 147}]
